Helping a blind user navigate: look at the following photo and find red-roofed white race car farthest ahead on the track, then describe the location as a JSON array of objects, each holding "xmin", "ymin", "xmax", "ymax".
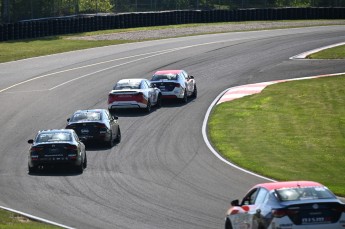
[{"xmin": 151, "ymin": 70, "xmax": 198, "ymax": 103}]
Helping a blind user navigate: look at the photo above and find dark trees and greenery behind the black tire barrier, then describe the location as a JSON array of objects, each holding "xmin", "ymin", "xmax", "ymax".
[{"xmin": 0, "ymin": 0, "xmax": 345, "ymax": 23}]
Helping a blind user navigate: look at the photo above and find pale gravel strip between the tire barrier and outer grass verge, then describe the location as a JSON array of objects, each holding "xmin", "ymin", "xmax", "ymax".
[{"xmin": 69, "ymin": 20, "xmax": 345, "ymax": 41}]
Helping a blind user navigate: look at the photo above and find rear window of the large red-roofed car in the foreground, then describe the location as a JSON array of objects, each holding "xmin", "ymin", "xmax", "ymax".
[{"xmin": 275, "ymin": 186, "xmax": 335, "ymax": 201}]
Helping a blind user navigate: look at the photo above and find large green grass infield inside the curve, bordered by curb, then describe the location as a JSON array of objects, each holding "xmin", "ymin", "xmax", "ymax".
[{"xmin": 209, "ymin": 75, "xmax": 345, "ymax": 196}]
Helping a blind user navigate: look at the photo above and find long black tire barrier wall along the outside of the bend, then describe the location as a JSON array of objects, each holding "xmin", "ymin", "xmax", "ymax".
[{"xmin": 0, "ymin": 7, "xmax": 345, "ymax": 41}]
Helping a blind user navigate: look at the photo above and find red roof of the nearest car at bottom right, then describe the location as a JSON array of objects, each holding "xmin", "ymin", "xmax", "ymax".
[{"xmin": 253, "ymin": 181, "xmax": 324, "ymax": 191}]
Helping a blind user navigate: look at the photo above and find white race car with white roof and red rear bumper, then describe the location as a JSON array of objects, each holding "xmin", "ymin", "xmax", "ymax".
[{"xmin": 108, "ymin": 79, "xmax": 162, "ymax": 112}]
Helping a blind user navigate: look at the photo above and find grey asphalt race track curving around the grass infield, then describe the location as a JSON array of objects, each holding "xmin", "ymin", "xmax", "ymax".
[{"xmin": 0, "ymin": 26, "xmax": 345, "ymax": 229}]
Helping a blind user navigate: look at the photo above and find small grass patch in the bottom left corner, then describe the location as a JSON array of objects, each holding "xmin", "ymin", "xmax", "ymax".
[{"xmin": 0, "ymin": 210, "xmax": 60, "ymax": 229}]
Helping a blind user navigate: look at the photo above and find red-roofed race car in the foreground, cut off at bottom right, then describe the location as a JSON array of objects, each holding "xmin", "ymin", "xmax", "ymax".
[{"xmin": 225, "ymin": 181, "xmax": 345, "ymax": 229}]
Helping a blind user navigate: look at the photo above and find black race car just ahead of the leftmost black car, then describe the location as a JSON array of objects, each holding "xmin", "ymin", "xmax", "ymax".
[{"xmin": 66, "ymin": 109, "xmax": 121, "ymax": 147}]
